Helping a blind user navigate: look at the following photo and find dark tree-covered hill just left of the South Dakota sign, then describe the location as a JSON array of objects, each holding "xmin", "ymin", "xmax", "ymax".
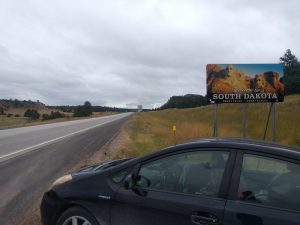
[{"xmin": 159, "ymin": 94, "xmax": 207, "ymax": 109}]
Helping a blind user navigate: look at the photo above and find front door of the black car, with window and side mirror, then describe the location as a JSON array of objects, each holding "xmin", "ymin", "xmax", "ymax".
[{"xmin": 111, "ymin": 149, "xmax": 234, "ymax": 225}]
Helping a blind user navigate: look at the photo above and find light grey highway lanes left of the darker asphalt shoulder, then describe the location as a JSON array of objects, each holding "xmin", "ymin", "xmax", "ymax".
[{"xmin": 0, "ymin": 113, "xmax": 130, "ymax": 162}]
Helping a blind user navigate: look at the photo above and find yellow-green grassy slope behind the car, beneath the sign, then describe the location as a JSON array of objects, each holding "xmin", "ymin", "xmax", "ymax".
[{"xmin": 114, "ymin": 95, "xmax": 300, "ymax": 158}]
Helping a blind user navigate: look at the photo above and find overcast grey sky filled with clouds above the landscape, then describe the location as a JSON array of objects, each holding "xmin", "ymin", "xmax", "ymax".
[{"xmin": 0, "ymin": 0, "xmax": 300, "ymax": 108}]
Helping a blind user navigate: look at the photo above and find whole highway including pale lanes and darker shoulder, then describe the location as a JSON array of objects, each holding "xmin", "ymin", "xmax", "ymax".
[{"xmin": 0, "ymin": 113, "xmax": 131, "ymax": 225}]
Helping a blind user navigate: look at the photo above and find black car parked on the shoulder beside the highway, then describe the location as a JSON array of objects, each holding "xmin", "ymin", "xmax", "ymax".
[{"xmin": 41, "ymin": 139, "xmax": 300, "ymax": 225}]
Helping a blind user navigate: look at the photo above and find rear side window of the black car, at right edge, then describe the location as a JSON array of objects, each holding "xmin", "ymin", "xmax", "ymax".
[{"xmin": 238, "ymin": 154, "xmax": 300, "ymax": 210}]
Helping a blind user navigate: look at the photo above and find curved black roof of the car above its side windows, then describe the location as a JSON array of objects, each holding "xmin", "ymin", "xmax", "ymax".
[{"xmin": 137, "ymin": 138, "xmax": 300, "ymax": 161}]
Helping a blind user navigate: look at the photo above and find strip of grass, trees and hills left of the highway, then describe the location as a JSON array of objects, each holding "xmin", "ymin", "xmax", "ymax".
[{"xmin": 0, "ymin": 99, "xmax": 137, "ymax": 129}]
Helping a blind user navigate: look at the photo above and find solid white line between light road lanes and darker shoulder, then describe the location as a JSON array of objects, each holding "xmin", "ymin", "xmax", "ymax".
[{"xmin": 0, "ymin": 120, "xmax": 114, "ymax": 162}]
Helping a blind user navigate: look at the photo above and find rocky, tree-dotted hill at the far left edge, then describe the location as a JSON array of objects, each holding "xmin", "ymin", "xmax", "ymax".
[{"xmin": 0, "ymin": 99, "xmax": 46, "ymax": 112}]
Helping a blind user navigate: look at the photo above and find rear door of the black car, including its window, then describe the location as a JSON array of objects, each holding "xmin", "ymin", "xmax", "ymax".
[{"xmin": 224, "ymin": 152, "xmax": 300, "ymax": 225}]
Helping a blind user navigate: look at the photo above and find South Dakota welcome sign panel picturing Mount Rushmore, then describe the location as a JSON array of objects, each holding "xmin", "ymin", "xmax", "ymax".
[{"xmin": 206, "ymin": 64, "xmax": 284, "ymax": 103}]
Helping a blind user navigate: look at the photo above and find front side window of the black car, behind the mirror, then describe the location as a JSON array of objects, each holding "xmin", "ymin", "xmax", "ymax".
[{"xmin": 136, "ymin": 151, "xmax": 229, "ymax": 196}]
